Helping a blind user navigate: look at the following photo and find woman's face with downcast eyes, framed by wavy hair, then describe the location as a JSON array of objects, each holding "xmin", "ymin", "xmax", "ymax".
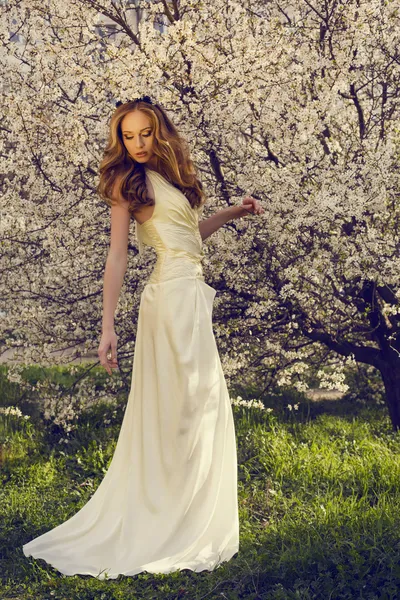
[{"xmin": 121, "ymin": 110, "xmax": 154, "ymax": 163}]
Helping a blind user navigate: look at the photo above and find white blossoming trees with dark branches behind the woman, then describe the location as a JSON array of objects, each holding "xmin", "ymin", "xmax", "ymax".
[{"xmin": 0, "ymin": 0, "xmax": 400, "ymax": 429}]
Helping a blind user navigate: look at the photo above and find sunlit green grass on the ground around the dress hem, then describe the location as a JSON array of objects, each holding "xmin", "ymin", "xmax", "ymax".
[{"xmin": 0, "ymin": 366, "xmax": 400, "ymax": 600}]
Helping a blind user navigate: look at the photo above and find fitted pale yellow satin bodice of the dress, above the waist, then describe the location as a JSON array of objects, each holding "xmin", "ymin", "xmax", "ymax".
[{"xmin": 135, "ymin": 167, "xmax": 203, "ymax": 283}]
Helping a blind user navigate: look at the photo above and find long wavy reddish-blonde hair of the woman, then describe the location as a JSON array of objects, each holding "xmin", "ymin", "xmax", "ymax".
[{"xmin": 96, "ymin": 99, "xmax": 205, "ymax": 217}]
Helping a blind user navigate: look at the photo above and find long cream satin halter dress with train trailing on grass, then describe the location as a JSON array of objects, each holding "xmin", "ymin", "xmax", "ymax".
[{"xmin": 23, "ymin": 167, "xmax": 239, "ymax": 579}]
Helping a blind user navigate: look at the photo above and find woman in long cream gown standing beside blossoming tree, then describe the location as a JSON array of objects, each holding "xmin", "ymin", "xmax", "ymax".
[{"xmin": 23, "ymin": 96, "xmax": 264, "ymax": 579}]
